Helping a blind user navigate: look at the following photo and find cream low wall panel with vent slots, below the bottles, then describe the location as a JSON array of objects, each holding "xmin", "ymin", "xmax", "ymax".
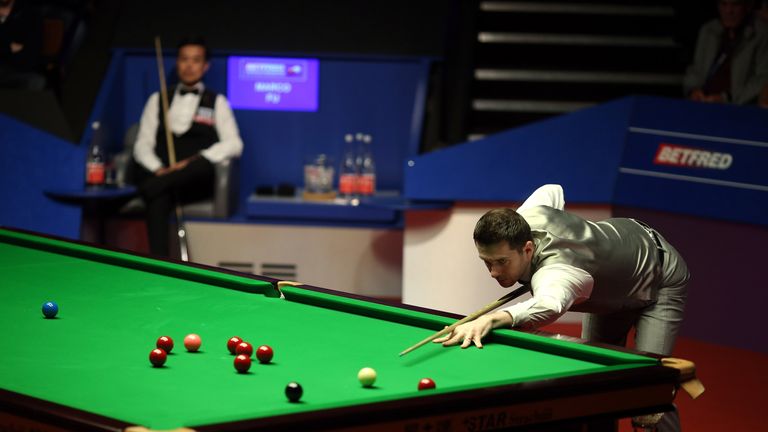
[{"xmin": 187, "ymin": 222, "xmax": 403, "ymax": 298}]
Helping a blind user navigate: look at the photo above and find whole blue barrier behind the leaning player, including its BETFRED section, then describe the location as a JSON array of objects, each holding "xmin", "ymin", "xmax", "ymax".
[{"xmin": 404, "ymin": 96, "xmax": 768, "ymax": 225}]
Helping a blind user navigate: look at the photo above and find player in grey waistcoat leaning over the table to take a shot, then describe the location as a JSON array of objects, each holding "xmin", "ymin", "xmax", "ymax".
[{"xmin": 435, "ymin": 185, "xmax": 689, "ymax": 430}]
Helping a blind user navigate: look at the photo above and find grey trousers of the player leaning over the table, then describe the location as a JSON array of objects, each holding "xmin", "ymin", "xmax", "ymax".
[{"xmin": 581, "ymin": 233, "xmax": 690, "ymax": 432}]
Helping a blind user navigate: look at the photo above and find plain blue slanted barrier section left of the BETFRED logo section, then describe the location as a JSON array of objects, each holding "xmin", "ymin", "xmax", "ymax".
[{"xmin": 405, "ymin": 99, "xmax": 631, "ymax": 203}]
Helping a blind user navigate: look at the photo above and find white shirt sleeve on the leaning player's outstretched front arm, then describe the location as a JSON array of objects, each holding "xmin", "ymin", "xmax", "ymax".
[{"xmin": 502, "ymin": 264, "xmax": 594, "ymax": 329}]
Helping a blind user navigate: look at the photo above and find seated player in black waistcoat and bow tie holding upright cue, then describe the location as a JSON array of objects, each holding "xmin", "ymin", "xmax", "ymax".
[{"xmin": 133, "ymin": 37, "xmax": 243, "ymax": 256}]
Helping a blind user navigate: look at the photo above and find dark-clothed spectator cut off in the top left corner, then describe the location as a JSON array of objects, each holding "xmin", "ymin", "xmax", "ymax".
[{"xmin": 0, "ymin": 0, "xmax": 45, "ymax": 90}]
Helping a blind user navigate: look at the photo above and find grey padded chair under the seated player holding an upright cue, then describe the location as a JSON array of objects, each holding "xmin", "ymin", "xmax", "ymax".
[{"xmin": 114, "ymin": 123, "xmax": 240, "ymax": 219}]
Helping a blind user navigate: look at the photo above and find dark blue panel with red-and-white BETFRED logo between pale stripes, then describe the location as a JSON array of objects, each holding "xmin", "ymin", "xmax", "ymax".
[{"xmin": 614, "ymin": 122, "xmax": 768, "ymax": 225}]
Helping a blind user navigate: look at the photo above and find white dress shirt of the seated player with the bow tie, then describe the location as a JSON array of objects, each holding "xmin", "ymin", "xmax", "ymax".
[{"xmin": 133, "ymin": 83, "xmax": 243, "ymax": 172}]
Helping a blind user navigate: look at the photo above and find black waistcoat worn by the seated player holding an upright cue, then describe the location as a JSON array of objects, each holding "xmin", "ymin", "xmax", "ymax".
[{"xmin": 155, "ymin": 87, "xmax": 219, "ymax": 166}]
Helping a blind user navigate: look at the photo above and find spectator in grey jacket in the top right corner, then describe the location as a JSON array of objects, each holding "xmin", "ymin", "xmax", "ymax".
[{"xmin": 683, "ymin": 0, "xmax": 768, "ymax": 105}]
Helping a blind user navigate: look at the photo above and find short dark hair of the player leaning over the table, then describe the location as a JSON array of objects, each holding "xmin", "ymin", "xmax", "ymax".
[{"xmin": 473, "ymin": 208, "xmax": 533, "ymax": 250}]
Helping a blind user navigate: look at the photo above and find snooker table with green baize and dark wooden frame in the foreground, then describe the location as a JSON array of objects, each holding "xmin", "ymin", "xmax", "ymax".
[{"xmin": 0, "ymin": 228, "xmax": 679, "ymax": 431}]
